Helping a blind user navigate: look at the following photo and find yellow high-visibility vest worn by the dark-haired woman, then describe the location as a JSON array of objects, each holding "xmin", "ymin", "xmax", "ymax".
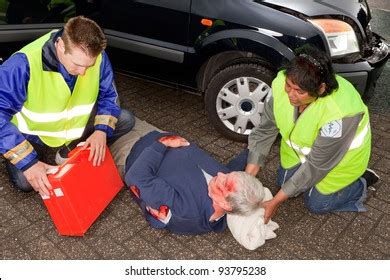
[{"xmin": 272, "ymin": 71, "xmax": 371, "ymax": 194}]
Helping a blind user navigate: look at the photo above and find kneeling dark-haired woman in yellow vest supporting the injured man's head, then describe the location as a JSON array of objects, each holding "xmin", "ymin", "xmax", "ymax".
[{"xmin": 246, "ymin": 46, "xmax": 379, "ymax": 223}]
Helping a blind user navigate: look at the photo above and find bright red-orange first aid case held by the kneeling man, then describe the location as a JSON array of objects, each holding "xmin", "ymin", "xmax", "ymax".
[{"xmin": 42, "ymin": 147, "xmax": 123, "ymax": 236}]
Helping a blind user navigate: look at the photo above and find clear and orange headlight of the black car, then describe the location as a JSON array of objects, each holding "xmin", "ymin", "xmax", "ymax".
[{"xmin": 309, "ymin": 19, "xmax": 359, "ymax": 57}]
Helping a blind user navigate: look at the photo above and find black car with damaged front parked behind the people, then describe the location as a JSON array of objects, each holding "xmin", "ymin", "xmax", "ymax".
[{"xmin": 0, "ymin": 0, "xmax": 389, "ymax": 141}]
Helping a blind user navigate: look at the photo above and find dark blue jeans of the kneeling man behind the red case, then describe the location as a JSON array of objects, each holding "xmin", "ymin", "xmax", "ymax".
[{"xmin": 5, "ymin": 109, "xmax": 135, "ymax": 192}]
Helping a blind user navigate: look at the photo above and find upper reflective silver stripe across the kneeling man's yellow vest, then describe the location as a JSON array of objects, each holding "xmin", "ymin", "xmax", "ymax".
[{"xmin": 17, "ymin": 104, "xmax": 94, "ymax": 123}]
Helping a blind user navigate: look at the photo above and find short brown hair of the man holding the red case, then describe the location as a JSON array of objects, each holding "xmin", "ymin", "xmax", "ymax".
[{"xmin": 61, "ymin": 16, "xmax": 107, "ymax": 57}]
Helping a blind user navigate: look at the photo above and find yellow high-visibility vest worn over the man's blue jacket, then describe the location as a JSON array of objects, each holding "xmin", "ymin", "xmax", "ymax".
[{"xmin": 12, "ymin": 33, "xmax": 102, "ymax": 147}]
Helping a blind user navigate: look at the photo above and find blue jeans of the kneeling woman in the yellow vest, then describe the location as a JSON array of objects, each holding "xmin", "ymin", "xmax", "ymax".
[{"xmin": 277, "ymin": 165, "xmax": 367, "ymax": 214}]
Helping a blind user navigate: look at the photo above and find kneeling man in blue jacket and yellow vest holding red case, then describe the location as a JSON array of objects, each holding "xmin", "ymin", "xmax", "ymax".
[{"xmin": 0, "ymin": 16, "xmax": 134, "ymax": 195}]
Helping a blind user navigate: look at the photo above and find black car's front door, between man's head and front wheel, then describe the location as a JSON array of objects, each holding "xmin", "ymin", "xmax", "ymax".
[{"xmin": 101, "ymin": 0, "xmax": 191, "ymax": 63}]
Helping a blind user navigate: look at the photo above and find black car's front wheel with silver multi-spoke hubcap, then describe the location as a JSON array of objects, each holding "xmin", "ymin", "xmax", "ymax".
[{"xmin": 205, "ymin": 64, "xmax": 275, "ymax": 142}]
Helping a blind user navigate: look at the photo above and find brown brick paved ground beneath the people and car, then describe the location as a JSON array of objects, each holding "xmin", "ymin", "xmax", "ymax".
[{"xmin": 0, "ymin": 74, "xmax": 390, "ymax": 259}]
